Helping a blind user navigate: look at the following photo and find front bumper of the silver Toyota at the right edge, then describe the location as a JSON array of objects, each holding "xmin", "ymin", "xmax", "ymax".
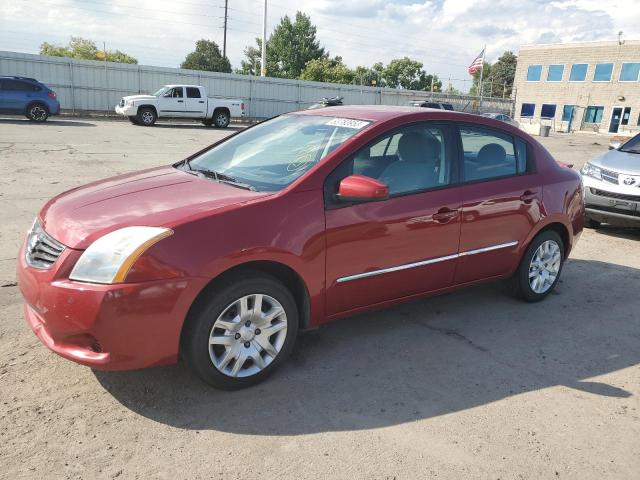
[{"xmin": 582, "ymin": 176, "xmax": 640, "ymax": 226}]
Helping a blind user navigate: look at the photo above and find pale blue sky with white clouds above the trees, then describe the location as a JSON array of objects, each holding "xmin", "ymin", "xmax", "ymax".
[{"xmin": 0, "ymin": 0, "xmax": 640, "ymax": 91}]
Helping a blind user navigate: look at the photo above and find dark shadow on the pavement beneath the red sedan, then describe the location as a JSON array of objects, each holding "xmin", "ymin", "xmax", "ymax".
[{"xmin": 95, "ymin": 260, "xmax": 640, "ymax": 435}]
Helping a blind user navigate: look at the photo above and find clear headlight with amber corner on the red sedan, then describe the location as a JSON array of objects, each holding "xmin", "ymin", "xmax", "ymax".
[{"xmin": 69, "ymin": 227, "xmax": 173, "ymax": 284}]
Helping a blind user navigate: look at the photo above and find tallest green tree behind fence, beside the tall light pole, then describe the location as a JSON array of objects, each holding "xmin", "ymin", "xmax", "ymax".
[{"xmin": 240, "ymin": 12, "xmax": 327, "ymax": 78}]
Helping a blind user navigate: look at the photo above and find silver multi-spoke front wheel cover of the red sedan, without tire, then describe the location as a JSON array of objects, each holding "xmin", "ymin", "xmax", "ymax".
[{"xmin": 209, "ymin": 293, "xmax": 287, "ymax": 377}]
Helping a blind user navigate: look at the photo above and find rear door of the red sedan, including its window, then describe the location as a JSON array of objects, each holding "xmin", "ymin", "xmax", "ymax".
[{"xmin": 455, "ymin": 124, "xmax": 542, "ymax": 284}]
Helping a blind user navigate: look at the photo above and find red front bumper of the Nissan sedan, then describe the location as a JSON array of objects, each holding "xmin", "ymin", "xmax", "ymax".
[{"xmin": 17, "ymin": 242, "xmax": 206, "ymax": 370}]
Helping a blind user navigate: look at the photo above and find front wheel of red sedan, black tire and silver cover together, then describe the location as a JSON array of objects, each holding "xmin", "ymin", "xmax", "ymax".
[{"xmin": 181, "ymin": 271, "xmax": 298, "ymax": 390}]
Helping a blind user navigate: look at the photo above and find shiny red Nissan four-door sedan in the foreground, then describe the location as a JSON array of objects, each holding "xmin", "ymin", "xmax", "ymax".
[{"xmin": 18, "ymin": 106, "xmax": 584, "ymax": 388}]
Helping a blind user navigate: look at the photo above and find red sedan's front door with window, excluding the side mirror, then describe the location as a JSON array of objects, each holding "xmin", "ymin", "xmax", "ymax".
[{"xmin": 325, "ymin": 123, "xmax": 461, "ymax": 315}]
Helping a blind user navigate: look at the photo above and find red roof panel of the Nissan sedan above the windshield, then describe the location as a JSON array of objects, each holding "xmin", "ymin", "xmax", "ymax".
[{"xmin": 291, "ymin": 105, "xmax": 492, "ymax": 123}]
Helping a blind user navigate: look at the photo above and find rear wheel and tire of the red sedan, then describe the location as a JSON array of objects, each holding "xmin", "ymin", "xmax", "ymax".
[{"xmin": 511, "ymin": 230, "xmax": 564, "ymax": 302}]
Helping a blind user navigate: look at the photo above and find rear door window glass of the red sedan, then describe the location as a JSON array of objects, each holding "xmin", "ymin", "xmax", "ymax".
[{"xmin": 460, "ymin": 125, "xmax": 531, "ymax": 182}]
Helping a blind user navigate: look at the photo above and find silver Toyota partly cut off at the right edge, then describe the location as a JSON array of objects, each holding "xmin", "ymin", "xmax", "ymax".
[{"xmin": 581, "ymin": 134, "xmax": 640, "ymax": 227}]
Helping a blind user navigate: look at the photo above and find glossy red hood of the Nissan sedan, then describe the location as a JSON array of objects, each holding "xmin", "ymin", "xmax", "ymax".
[{"xmin": 40, "ymin": 167, "xmax": 272, "ymax": 249}]
